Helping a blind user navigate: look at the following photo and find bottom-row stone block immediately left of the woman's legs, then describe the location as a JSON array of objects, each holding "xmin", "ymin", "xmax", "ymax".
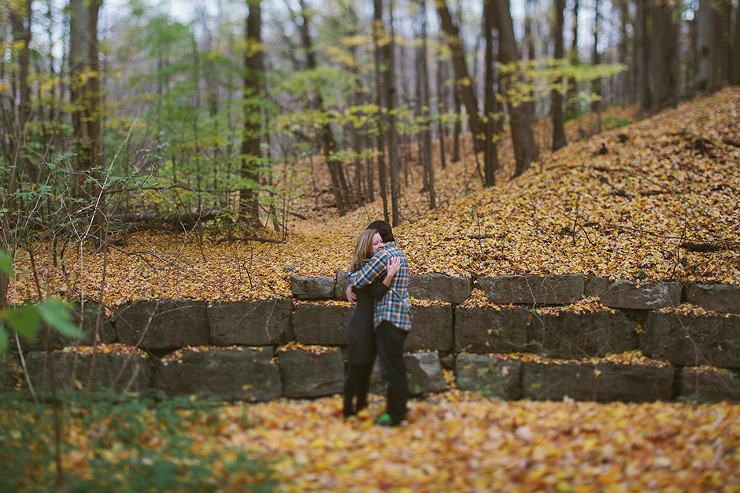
[{"xmin": 278, "ymin": 346, "xmax": 344, "ymax": 399}]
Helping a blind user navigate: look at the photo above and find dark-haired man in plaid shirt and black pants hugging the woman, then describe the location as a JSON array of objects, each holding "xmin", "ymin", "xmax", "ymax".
[{"xmin": 347, "ymin": 221, "xmax": 411, "ymax": 426}]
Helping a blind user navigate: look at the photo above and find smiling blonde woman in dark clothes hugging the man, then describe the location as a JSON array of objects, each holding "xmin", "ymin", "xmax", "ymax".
[{"xmin": 343, "ymin": 229, "xmax": 401, "ymax": 418}]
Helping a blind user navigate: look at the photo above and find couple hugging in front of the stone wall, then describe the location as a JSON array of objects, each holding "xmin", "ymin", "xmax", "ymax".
[{"xmin": 343, "ymin": 221, "xmax": 411, "ymax": 426}]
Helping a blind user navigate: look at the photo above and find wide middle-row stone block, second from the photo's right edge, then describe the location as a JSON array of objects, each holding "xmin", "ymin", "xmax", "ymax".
[{"xmin": 528, "ymin": 311, "xmax": 640, "ymax": 359}]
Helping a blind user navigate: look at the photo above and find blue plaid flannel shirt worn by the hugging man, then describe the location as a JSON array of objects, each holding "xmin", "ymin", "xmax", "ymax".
[{"xmin": 348, "ymin": 241, "xmax": 411, "ymax": 331}]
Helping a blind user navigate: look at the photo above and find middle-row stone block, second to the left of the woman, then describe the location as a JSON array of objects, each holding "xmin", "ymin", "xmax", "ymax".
[{"xmin": 207, "ymin": 298, "xmax": 293, "ymax": 346}]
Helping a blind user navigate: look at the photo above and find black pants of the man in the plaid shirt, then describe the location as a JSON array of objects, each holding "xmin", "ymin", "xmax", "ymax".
[{"xmin": 375, "ymin": 321, "xmax": 409, "ymax": 424}]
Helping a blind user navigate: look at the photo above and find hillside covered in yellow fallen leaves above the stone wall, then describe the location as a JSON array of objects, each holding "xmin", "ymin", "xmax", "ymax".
[{"xmin": 9, "ymin": 87, "xmax": 740, "ymax": 305}]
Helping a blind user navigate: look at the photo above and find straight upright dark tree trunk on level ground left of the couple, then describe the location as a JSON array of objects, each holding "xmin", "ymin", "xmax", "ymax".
[{"xmin": 239, "ymin": 0, "xmax": 265, "ymax": 228}]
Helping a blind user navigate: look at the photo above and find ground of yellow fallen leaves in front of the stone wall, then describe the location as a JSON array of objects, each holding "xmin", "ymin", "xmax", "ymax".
[{"xmin": 0, "ymin": 391, "xmax": 740, "ymax": 492}]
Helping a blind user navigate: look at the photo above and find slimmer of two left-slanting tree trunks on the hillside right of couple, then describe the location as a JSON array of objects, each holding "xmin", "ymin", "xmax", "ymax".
[{"xmin": 435, "ymin": 0, "xmax": 485, "ymax": 152}]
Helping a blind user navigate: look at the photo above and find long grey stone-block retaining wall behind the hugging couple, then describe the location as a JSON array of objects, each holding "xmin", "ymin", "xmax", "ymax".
[{"xmin": 0, "ymin": 273, "xmax": 740, "ymax": 402}]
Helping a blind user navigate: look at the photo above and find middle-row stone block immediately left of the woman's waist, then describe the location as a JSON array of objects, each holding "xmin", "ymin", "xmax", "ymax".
[{"xmin": 293, "ymin": 303, "xmax": 355, "ymax": 346}]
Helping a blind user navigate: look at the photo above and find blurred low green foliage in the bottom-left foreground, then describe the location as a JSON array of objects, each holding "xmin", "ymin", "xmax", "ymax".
[{"xmin": 0, "ymin": 397, "xmax": 273, "ymax": 492}]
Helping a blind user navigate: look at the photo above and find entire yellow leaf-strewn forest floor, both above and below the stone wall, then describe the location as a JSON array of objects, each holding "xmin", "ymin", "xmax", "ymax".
[{"xmin": 5, "ymin": 87, "xmax": 740, "ymax": 492}]
